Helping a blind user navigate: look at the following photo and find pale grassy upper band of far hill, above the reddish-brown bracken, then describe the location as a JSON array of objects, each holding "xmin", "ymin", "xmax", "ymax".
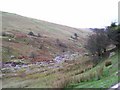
[{"xmin": 2, "ymin": 12, "xmax": 91, "ymax": 38}]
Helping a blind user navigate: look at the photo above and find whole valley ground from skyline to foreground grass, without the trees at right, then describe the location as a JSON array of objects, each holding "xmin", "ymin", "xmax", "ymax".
[{"xmin": 0, "ymin": 12, "xmax": 120, "ymax": 89}]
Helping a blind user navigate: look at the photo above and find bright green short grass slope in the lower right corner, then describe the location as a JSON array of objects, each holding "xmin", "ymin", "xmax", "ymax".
[{"xmin": 68, "ymin": 51, "xmax": 119, "ymax": 88}]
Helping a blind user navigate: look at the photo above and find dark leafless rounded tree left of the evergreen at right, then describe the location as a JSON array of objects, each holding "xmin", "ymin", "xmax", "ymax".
[{"xmin": 86, "ymin": 29, "xmax": 109, "ymax": 57}]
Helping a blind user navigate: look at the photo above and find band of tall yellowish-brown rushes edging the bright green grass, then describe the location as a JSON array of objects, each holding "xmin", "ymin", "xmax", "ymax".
[{"xmin": 53, "ymin": 66, "xmax": 104, "ymax": 88}]
